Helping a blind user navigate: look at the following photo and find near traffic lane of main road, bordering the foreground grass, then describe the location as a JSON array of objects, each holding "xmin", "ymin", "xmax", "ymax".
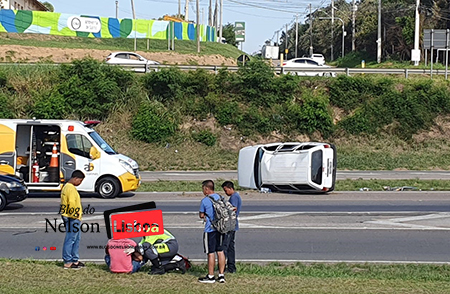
[{"xmin": 0, "ymin": 228, "xmax": 450, "ymax": 263}]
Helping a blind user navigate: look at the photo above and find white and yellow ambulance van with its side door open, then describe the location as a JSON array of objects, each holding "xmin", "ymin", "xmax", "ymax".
[{"xmin": 0, "ymin": 119, "xmax": 141, "ymax": 198}]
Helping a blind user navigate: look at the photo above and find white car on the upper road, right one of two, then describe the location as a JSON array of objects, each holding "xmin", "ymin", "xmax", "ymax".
[{"xmin": 282, "ymin": 57, "xmax": 336, "ymax": 77}]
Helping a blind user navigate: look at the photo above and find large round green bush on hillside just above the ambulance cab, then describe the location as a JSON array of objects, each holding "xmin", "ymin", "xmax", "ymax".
[{"xmin": 58, "ymin": 58, "xmax": 134, "ymax": 119}]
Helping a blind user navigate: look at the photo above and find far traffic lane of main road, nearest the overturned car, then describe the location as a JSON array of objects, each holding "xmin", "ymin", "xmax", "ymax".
[{"xmin": 6, "ymin": 192, "xmax": 450, "ymax": 217}]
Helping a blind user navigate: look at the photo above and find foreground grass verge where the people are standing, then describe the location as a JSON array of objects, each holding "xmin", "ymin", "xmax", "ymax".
[{"xmin": 0, "ymin": 259, "xmax": 450, "ymax": 294}]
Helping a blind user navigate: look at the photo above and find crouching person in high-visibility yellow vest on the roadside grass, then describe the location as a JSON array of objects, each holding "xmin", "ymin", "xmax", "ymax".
[{"xmin": 139, "ymin": 229, "xmax": 186, "ymax": 275}]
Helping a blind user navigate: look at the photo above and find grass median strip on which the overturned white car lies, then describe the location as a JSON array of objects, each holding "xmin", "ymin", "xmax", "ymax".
[{"xmin": 137, "ymin": 179, "xmax": 450, "ymax": 192}]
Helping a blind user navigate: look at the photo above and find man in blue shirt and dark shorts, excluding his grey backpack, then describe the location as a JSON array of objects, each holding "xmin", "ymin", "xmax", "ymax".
[{"xmin": 198, "ymin": 180, "xmax": 225, "ymax": 283}]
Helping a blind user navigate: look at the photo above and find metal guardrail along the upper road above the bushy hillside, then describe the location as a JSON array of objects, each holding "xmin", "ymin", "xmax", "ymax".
[{"xmin": 0, "ymin": 63, "xmax": 448, "ymax": 78}]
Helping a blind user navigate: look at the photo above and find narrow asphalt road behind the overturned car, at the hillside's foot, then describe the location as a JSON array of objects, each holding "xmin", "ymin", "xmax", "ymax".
[{"xmin": 141, "ymin": 170, "xmax": 450, "ymax": 182}]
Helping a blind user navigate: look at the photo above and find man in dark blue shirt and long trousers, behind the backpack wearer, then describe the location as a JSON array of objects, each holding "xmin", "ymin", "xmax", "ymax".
[{"xmin": 222, "ymin": 181, "xmax": 242, "ymax": 273}]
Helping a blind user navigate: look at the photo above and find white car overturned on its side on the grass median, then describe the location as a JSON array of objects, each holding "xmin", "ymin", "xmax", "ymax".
[{"xmin": 238, "ymin": 142, "xmax": 336, "ymax": 193}]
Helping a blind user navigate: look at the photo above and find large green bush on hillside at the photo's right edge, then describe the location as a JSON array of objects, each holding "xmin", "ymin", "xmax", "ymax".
[{"xmin": 339, "ymin": 80, "xmax": 450, "ymax": 140}]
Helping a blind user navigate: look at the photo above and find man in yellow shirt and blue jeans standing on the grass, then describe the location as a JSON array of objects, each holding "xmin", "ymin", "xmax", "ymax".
[{"xmin": 60, "ymin": 170, "xmax": 85, "ymax": 269}]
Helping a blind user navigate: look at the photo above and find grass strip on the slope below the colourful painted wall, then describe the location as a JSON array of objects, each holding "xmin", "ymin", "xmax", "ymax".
[{"xmin": 0, "ymin": 33, "xmax": 242, "ymax": 58}]
